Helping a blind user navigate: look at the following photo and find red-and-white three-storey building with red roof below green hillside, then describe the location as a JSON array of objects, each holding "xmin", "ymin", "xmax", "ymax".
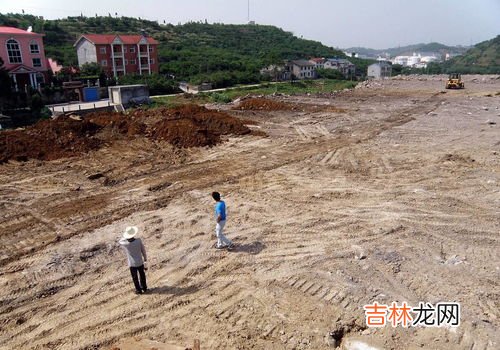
[{"xmin": 74, "ymin": 34, "xmax": 159, "ymax": 77}]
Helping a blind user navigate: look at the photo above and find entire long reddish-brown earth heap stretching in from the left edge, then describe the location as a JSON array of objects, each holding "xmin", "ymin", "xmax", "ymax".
[{"xmin": 0, "ymin": 105, "xmax": 251, "ymax": 164}]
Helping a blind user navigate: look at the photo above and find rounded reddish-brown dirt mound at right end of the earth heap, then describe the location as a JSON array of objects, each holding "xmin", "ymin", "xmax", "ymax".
[{"xmin": 150, "ymin": 105, "xmax": 250, "ymax": 147}]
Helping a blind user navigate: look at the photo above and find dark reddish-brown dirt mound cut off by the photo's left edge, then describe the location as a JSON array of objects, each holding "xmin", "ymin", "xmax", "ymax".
[{"xmin": 0, "ymin": 117, "xmax": 102, "ymax": 163}]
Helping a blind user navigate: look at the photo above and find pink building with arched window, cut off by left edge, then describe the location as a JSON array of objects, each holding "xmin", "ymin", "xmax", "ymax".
[{"xmin": 0, "ymin": 26, "xmax": 48, "ymax": 91}]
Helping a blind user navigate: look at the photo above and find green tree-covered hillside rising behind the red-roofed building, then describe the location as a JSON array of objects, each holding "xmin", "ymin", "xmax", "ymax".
[{"xmin": 0, "ymin": 14, "xmax": 350, "ymax": 86}]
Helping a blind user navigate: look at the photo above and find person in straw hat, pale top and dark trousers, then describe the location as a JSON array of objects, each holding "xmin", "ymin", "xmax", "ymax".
[{"xmin": 119, "ymin": 226, "xmax": 148, "ymax": 294}]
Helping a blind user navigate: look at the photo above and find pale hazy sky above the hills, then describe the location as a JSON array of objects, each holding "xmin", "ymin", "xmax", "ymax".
[{"xmin": 0, "ymin": 0, "xmax": 500, "ymax": 49}]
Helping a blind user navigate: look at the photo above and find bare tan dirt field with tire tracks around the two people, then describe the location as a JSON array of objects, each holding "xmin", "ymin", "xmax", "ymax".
[{"xmin": 0, "ymin": 76, "xmax": 500, "ymax": 350}]
